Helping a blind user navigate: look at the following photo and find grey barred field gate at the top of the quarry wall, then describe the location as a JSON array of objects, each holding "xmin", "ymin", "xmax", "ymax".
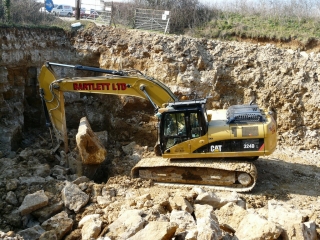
[{"xmin": 134, "ymin": 8, "xmax": 170, "ymax": 33}]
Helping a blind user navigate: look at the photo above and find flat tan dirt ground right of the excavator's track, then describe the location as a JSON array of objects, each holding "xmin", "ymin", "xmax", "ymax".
[{"xmin": 242, "ymin": 147, "xmax": 320, "ymax": 214}]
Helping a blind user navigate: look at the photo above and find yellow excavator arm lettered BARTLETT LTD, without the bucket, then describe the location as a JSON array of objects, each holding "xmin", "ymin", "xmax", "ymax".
[{"xmin": 38, "ymin": 62, "xmax": 178, "ymax": 152}]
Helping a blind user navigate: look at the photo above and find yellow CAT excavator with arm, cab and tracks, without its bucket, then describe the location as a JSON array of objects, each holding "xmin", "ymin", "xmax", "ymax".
[{"xmin": 38, "ymin": 62, "xmax": 277, "ymax": 192}]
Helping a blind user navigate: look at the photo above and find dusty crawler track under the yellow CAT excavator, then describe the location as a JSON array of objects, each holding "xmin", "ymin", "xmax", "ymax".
[{"xmin": 131, "ymin": 157, "xmax": 257, "ymax": 192}]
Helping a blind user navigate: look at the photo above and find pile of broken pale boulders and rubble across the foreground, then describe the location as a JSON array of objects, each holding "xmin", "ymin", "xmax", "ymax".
[{"xmin": 0, "ymin": 144, "xmax": 320, "ymax": 240}]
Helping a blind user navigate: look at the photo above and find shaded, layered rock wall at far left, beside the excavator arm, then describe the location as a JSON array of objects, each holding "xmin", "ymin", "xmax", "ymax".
[{"xmin": 0, "ymin": 28, "xmax": 77, "ymax": 153}]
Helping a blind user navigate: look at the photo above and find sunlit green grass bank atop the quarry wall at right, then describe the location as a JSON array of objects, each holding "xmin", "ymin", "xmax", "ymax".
[{"xmin": 195, "ymin": 12, "xmax": 320, "ymax": 42}]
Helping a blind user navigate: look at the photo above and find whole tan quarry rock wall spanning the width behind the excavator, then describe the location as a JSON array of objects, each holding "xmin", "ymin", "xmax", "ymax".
[{"xmin": 0, "ymin": 24, "xmax": 320, "ymax": 155}]
